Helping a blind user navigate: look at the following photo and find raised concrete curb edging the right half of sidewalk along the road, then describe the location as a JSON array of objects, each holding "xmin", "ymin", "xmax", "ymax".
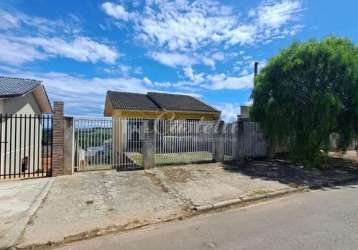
[{"xmin": 192, "ymin": 187, "xmax": 309, "ymax": 213}]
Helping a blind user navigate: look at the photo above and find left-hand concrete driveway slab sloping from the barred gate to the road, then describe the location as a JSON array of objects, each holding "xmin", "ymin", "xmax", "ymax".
[{"xmin": 18, "ymin": 171, "xmax": 188, "ymax": 247}]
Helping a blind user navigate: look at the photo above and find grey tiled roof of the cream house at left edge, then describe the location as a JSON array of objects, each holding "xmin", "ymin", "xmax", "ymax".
[{"xmin": 0, "ymin": 76, "xmax": 41, "ymax": 98}]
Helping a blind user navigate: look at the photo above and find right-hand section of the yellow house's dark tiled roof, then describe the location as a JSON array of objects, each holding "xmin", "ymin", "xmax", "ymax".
[{"xmin": 147, "ymin": 92, "xmax": 219, "ymax": 112}]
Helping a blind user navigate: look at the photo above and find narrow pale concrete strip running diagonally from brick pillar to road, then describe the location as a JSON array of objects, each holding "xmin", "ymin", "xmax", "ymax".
[{"xmin": 0, "ymin": 178, "xmax": 55, "ymax": 249}]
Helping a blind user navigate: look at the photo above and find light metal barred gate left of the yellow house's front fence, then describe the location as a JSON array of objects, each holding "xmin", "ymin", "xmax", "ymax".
[{"xmin": 74, "ymin": 117, "xmax": 144, "ymax": 171}]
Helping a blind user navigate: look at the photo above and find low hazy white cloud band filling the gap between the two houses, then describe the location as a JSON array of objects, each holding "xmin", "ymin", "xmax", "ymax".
[{"xmin": 2, "ymin": 71, "xmax": 150, "ymax": 115}]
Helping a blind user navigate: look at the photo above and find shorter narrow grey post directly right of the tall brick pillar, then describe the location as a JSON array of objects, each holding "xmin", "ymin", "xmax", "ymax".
[{"xmin": 64, "ymin": 117, "xmax": 74, "ymax": 175}]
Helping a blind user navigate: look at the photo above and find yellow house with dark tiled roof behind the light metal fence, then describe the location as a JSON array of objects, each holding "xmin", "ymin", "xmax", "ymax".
[{"xmin": 104, "ymin": 91, "xmax": 221, "ymax": 155}]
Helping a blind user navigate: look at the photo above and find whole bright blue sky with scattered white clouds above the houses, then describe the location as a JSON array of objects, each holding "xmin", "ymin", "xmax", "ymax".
[{"xmin": 0, "ymin": 0, "xmax": 358, "ymax": 120}]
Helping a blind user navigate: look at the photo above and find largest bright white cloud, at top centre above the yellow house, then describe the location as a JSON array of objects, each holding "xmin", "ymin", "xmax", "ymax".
[{"xmin": 102, "ymin": 0, "xmax": 303, "ymax": 76}]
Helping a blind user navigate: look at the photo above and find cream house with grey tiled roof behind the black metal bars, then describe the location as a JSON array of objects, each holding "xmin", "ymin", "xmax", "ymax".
[{"xmin": 0, "ymin": 77, "xmax": 52, "ymax": 176}]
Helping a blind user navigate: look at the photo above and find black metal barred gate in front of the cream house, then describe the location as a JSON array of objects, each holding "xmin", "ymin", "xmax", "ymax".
[{"xmin": 0, "ymin": 114, "xmax": 53, "ymax": 179}]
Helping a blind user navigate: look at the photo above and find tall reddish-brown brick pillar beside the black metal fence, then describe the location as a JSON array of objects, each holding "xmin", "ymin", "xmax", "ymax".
[{"xmin": 52, "ymin": 101, "xmax": 65, "ymax": 176}]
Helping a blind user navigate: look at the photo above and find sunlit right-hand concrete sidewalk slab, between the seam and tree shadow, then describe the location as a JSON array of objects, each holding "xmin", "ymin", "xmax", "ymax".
[{"xmin": 147, "ymin": 163, "xmax": 292, "ymax": 206}]
